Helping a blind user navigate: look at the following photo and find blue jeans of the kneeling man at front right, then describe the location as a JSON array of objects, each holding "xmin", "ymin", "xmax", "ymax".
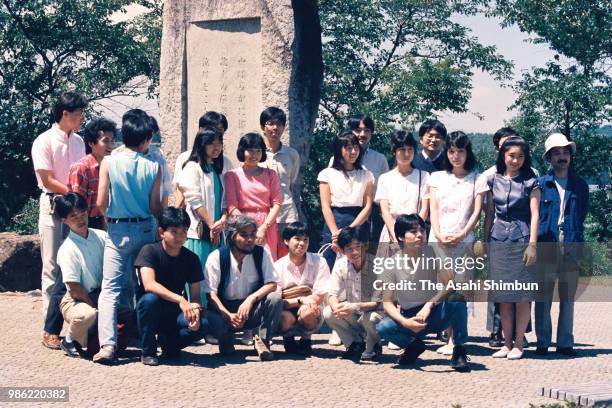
[{"xmin": 376, "ymin": 302, "xmax": 467, "ymax": 348}]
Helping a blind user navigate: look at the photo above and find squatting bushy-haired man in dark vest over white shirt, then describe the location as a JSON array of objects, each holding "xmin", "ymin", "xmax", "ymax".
[{"xmin": 204, "ymin": 214, "xmax": 283, "ymax": 361}]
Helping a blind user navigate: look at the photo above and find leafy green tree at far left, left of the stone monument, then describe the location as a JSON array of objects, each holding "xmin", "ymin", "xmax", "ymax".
[{"xmin": 0, "ymin": 0, "xmax": 159, "ymax": 229}]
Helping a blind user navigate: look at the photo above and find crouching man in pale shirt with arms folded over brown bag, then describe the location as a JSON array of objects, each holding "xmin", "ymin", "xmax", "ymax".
[{"xmin": 274, "ymin": 222, "xmax": 329, "ymax": 355}]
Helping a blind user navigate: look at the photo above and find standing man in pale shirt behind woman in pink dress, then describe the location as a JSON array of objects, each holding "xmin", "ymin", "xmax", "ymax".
[{"xmin": 259, "ymin": 106, "xmax": 300, "ymax": 258}]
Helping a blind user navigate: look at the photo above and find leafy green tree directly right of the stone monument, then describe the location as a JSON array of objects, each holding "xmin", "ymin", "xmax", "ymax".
[{"xmin": 302, "ymin": 0, "xmax": 512, "ymax": 246}]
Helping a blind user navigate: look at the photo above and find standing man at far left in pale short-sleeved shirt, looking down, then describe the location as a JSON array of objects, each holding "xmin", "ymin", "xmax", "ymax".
[{"xmin": 32, "ymin": 92, "xmax": 87, "ymax": 349}]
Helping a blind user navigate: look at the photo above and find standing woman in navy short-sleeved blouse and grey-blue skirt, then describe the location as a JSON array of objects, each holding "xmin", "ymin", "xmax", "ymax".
[{"xmin": 484, "ymin": 137, "xmax": 540, "ymax": 360}]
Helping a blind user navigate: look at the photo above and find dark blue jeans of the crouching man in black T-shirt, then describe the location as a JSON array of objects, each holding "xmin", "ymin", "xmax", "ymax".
[{"xmin": 136, "ymin": 293, "xmax": 209, "ymax": 356}]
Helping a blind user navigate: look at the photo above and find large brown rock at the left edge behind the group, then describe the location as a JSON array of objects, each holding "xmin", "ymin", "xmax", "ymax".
[{"xmin": 0, "ymin": 232, "xmax": 42, "ymax": 292}]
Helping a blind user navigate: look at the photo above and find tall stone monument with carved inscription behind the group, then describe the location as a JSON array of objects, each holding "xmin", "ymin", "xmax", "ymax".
[{"xmin": 160, "ymin": 0, "xmax": 323, "ymax": 181}]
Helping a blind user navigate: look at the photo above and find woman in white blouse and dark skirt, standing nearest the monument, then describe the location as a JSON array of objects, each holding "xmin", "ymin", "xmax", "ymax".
[{"xmin": 317, "ymin": 130, "xmax": 374, "ymax": 270}]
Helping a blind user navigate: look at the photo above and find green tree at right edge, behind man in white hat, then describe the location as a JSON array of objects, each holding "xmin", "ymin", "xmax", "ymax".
[{"xmin": 493, "ymin": 0, "xmax": 612, "ymax": 241}]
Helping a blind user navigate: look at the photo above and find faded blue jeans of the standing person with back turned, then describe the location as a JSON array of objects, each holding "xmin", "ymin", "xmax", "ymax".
[{"xmin": 98, "ymin": 217, "xmax": 157, "ymax": 346}]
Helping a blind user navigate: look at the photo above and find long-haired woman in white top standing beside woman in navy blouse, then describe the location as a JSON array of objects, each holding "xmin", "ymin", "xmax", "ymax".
[{"xmin": 427, "ymin": 132, "xmax": 488, "ymax": 355}]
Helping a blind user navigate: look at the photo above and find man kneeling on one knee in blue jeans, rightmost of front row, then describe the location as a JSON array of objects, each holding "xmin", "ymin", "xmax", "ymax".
[{"xmin": 376, "ymin": 214, "xmax": 470, "ymax": 371}]
